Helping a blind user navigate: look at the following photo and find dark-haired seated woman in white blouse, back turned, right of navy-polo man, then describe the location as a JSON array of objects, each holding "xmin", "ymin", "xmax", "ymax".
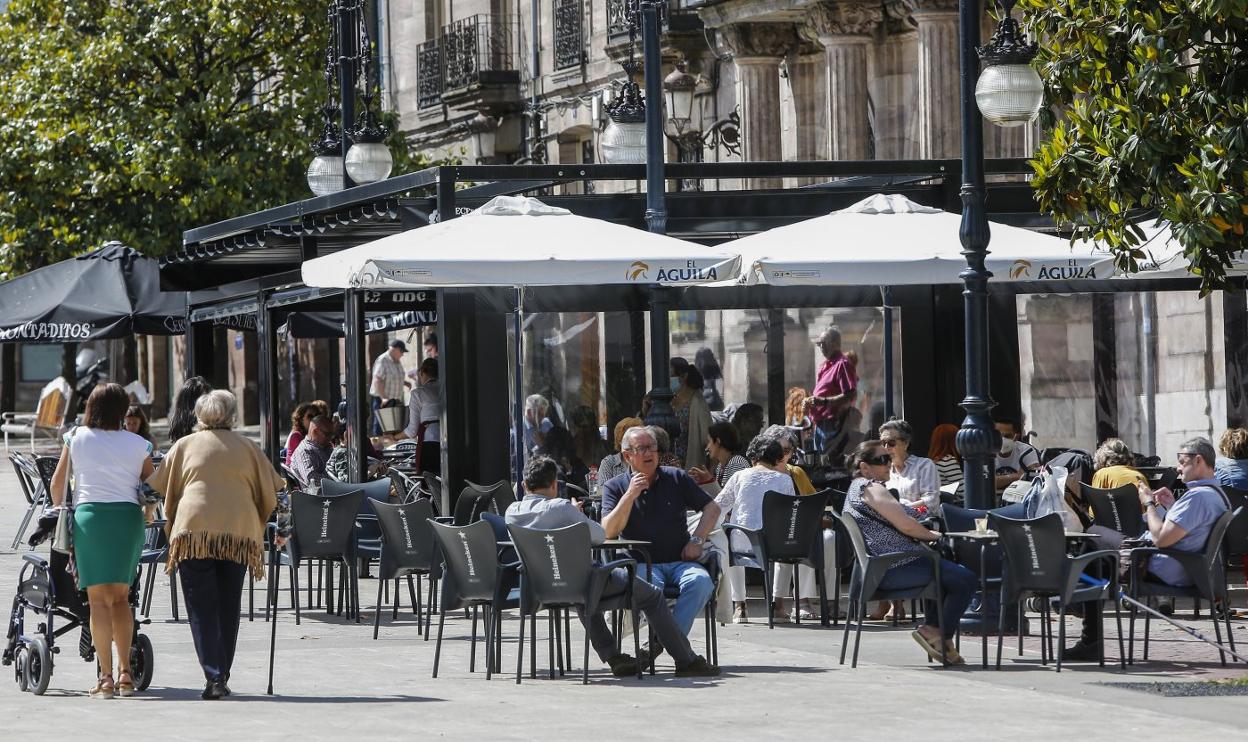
[{"xmin": 715, "ymin": 435, "xmax": 797, "ymax": 624}]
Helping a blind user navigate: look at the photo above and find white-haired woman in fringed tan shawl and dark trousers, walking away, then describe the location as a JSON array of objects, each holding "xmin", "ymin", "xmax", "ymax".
[{"xmin": 147, "ymin": 389, "xmax": 286, "ymax": 701}]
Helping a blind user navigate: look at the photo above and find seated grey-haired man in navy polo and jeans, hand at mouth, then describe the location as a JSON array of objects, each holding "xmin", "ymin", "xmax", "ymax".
[{"xmin": 603, "ymin": 428, "xmax": 719, "ymax": 648}]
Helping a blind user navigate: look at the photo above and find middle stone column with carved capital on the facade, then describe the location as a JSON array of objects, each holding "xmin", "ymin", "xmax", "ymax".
[{"xmin": 806, "ymin": 1, "xmax": 884, "ymax": 160}]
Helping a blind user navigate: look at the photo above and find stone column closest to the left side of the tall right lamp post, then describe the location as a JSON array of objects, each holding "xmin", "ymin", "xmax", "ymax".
[{"xmin": 912, "ymin": 0, "xmax": 962, "ymax": 158}]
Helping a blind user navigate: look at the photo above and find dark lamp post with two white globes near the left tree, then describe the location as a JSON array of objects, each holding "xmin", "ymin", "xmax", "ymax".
[{"xmin": 307, "ymin": 0, "xmax": 393, "ymax": 196}]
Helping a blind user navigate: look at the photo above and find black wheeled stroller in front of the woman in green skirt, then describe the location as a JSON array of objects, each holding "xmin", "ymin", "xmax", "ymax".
[{"xmin": 0, "ymin": 531, "xmax": 155, "ymax": 696}]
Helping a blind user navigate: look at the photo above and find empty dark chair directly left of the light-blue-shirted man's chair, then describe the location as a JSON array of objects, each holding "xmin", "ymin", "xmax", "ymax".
[{"xmin": 429, "ymin": 519, "xmax": 524, "ymax": 680}]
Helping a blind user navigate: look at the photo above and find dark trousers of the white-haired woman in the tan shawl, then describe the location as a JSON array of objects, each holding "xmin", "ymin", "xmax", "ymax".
[{"xmin": 177, "ymin": 559, "xmax": 247, "ymax": 681}]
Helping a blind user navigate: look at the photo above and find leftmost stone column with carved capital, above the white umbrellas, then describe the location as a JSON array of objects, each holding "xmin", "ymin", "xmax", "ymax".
[{"xmin": 719, "ymin": 24, "xmax": 797, "ymax": 188}]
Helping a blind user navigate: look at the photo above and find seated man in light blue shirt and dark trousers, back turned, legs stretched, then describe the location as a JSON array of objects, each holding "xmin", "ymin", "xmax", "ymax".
[{"xmin": 505, "ymin": 456, "xmax": 719, "ymax": 677}]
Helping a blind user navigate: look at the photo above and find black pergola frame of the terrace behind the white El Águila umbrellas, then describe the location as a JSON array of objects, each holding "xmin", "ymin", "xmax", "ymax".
[{"xmin": 168, "ymin": 160, "xmax": 1248, "ymax": 506}]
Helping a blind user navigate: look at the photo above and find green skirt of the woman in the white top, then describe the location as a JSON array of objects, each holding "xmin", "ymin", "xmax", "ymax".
[{"xmin": 74, "ymin": 503, "xmax": 144, "ymax": 589}]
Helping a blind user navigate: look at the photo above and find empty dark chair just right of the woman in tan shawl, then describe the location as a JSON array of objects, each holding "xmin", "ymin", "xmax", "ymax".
[{"xmin": 286, "ymin": 489, "xmax": 364, "ymax": 624}]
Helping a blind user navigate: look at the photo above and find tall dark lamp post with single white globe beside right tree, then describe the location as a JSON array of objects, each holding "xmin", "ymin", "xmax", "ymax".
[{"xmin": 957, "ymin": 0, "xmax": 1043, "ymax": 509}]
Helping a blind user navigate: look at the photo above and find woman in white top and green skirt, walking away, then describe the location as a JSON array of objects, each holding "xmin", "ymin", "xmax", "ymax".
[{"xmin": 52, "ymin": 384, "xmax": 152, "ymax": 698}]
